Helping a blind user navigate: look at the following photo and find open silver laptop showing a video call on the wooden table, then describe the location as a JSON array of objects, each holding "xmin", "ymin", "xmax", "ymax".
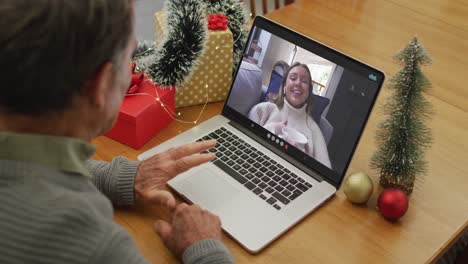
[{"xmin": 138, "ymin": 16, "xmax": 384, "ymax": 253}]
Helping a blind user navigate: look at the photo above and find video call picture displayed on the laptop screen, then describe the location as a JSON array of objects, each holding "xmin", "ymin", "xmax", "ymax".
[{"xmin": 227, "ymin": 27, "xmax": 379, "ymax": 178}]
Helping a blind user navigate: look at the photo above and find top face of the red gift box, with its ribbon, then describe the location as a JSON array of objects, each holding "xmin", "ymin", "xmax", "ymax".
[{"xmin": 119, "ymin": 78, "xmax": 172, "ymax": 124}]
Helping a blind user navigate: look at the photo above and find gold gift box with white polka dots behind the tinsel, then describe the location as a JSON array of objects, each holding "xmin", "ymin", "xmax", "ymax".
[{"xmin": 155, "ymin": 11, "xmax": 233, "ymax": 107}]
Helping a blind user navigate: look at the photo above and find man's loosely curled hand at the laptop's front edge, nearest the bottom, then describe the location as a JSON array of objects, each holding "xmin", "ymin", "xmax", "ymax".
[{"xmin": 154, "ymin": 203, "xmax": 222, "ymax": 258}]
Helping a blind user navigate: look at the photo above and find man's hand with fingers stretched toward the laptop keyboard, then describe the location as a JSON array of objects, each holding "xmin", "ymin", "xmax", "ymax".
[{"xmin": 135, "ymin": 140, "xmax": 216, "ymax": 208}]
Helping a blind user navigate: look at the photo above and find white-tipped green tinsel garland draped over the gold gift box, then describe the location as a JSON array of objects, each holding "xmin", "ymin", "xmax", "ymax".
[{"xmin": 134, "ymin": 0, "xmax": 248, "ymax": 86}]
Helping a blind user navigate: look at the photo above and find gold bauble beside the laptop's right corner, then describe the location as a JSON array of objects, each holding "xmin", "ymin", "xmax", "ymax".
[{"xmin": 343, "ymin": 172, "xmax": 374, "ymax": 204}]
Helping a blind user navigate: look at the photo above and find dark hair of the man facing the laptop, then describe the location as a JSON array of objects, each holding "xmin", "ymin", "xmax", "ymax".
[{"xmin": 0, "ymin": 0, "xmax": 132, "ymax": 115}]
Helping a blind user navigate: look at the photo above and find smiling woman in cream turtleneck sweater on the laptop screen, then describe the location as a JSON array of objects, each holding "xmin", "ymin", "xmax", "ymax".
[{"xmin": 249, "ymin": 62, "xmax": 331, "ymax": 168}]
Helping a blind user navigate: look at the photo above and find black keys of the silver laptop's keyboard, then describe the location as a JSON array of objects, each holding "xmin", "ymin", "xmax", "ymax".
[{"xmin": 197, "ymin": 127, "xmax": 312, "ymax": 210}]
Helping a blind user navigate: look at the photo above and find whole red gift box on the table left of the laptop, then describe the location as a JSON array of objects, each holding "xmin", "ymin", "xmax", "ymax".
[{"xmin": 105, "ymin": 77, "xmax": 175, "ymax": 149}]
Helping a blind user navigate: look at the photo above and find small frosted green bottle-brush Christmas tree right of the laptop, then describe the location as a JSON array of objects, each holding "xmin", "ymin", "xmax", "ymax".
[{"xmin": 371, "ymin": 37, "xmax": 432, "ymax": 194}]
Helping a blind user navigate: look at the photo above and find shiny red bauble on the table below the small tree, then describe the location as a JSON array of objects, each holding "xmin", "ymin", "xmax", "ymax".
[{"xmin": 377, "ymin": 188, "xmax": 408, "ymax": 221}]
